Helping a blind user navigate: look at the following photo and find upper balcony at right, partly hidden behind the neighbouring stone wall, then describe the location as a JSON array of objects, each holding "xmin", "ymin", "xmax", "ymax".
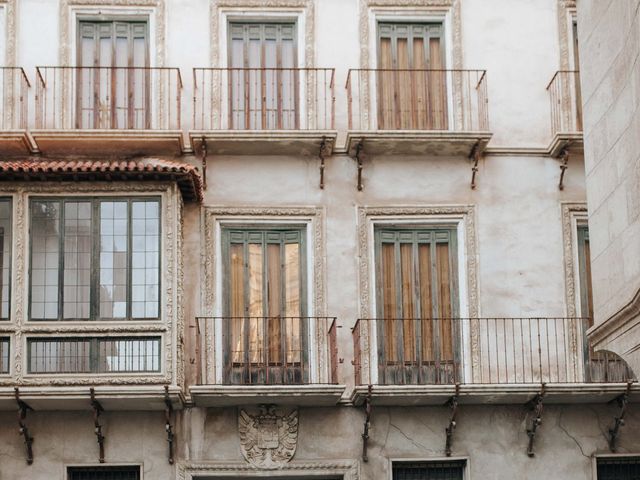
[{"xmin": 547, "ymin": 70, "xmax": 583, "ymax": 157}]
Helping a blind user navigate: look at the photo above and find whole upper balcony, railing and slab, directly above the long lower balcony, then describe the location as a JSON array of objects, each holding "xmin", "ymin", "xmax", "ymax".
[{"xmin": 346, "ymin": 69, "xmax": 491, "ymax": 156}]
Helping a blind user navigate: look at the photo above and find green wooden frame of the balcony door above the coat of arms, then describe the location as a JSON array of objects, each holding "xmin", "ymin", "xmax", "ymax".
[{"xmin": 220, "ymin": 223, "xmax": 311, "ymax": 384}]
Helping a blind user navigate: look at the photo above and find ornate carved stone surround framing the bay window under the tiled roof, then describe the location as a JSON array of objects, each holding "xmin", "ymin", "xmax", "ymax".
[{"xmin": 0, "ymin": 182, "xmax": 184, "ymax": 385}]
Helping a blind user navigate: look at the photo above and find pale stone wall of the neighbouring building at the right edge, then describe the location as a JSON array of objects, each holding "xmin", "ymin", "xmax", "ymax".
[{"xmin": 578, "ymin": 0, "xmax": 640, "ymax": 369}]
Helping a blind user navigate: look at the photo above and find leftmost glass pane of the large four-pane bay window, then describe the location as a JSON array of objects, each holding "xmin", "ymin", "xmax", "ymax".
[{"xmin": 31, "ymin": 200, "xmax": 60, "ymax": 320}]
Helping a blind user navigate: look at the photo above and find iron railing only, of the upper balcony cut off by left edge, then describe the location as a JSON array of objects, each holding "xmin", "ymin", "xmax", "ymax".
[{"xmin": 0, "ymin": 67, "xmax": 31, "ymax": 130}]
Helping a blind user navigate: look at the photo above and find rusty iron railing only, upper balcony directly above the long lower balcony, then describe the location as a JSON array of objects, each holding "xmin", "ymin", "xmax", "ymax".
[{"xmin": 346, "ymin": 69, "xmax": 489, "ymax": 132}]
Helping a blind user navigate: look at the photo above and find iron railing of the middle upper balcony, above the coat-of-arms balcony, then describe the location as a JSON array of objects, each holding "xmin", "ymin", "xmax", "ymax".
[{"xmin": 193, "ymin": 68, "xmax": 335, "ymax": 131}]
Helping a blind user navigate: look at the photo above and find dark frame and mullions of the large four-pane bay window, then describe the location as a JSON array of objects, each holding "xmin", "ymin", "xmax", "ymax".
[{"xmin": 27, "ymin": 196, "xmax": 163, "ymax": 322}]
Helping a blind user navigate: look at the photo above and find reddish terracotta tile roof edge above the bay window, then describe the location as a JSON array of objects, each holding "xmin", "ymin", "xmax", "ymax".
[{"xmin": 0, "ymin": 158, "xmax": 203, "ymax": 201}]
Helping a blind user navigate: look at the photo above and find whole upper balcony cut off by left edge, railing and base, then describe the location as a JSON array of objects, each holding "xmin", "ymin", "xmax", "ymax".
[{"xmin": 0, "ymin": 67, "xmax": 35, "ymax": 155}]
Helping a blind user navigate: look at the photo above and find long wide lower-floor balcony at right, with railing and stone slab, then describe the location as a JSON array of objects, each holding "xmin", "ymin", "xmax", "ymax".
[{"xmin": 352, "ymin": 318, "xmax": 640, "ymax": 405}]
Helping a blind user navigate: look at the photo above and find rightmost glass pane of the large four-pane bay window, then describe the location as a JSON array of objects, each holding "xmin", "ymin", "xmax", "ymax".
[{"xmin": 131, "ymin": 200, "xmax": 160, "ymax": 318}]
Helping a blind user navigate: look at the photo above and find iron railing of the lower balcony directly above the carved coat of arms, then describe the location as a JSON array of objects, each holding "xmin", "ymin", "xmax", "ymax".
[{"xmin": 196, "ymin": 317, "xmax": 338, "ymax": 385}]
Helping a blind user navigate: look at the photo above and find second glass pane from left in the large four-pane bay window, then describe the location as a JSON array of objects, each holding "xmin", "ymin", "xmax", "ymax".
[{"xmin": 62, "ymin": 202, "xmax": 92, "ymax": 319}]
